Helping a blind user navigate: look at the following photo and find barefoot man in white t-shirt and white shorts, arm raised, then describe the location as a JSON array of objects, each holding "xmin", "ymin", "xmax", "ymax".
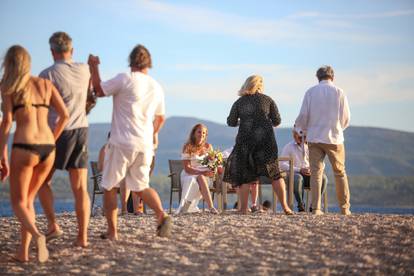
[{"xmin": 88, "ymin": 45, "xmax": 172, "ymax": 240}]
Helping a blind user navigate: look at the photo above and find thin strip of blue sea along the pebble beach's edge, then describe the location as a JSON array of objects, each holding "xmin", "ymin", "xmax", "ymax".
[{"xmin": 0, "ymin": 200, "xmax": 414, "ymax": 217}]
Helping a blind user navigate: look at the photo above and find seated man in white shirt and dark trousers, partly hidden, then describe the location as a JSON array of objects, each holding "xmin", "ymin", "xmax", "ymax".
[{"xmin": 279, "ymin": 127, "xmax": 328, "ymax": 212}]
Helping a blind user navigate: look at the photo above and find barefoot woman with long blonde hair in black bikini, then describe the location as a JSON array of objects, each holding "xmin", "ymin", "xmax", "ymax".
[{"xmin": 0, "ymin": 45, "xmax": 69, "ymax": 262}]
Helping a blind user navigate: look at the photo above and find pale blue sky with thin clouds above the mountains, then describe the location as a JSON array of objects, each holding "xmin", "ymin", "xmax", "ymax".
[{"xmin": 0, "ymin": 0, "xmax": 414, "ymax": 131}]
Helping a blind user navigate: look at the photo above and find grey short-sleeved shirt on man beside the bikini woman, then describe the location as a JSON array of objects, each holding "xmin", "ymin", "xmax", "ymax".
[{"xmin": 39, "ymin": 61, "xmax": 90, "ymax": 130}]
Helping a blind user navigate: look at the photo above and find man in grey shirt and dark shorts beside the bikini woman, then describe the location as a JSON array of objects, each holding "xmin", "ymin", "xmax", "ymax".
[{"xmin": 39, "ymin": 32, "xmax": 90, "ymax": 247}]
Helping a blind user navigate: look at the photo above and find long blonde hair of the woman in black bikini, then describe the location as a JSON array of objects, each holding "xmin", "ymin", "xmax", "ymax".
[{"xmin": 0, "ymin": 45, "xmax": 31, "ymax": 107}]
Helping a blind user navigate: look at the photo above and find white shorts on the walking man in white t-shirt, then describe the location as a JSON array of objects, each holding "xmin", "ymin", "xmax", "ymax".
[{"xmin": 101, "ymin": 144, "xmax": 154, "ymax": 192}]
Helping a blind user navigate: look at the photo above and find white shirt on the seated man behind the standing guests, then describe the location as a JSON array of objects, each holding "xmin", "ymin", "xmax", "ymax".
[{"xmin": 279, "ymin": 141, "xmax": 309, "ymax": 172}]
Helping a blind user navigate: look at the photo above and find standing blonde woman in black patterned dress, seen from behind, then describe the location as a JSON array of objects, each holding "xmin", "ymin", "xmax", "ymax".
[{"xmin": 223, "ymin": 75, "xmax": 293, "ymax": 215}]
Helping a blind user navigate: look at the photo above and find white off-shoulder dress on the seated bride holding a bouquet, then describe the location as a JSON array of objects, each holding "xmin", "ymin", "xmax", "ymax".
[{"xmin": 177, "ymin": 153, "xmax": 211, "ymax": 214}]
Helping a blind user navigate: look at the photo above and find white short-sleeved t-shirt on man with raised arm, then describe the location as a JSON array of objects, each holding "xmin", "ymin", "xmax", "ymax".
[{"xmin": 101, "ymin": 72, "xmax": 165, "ymax": 152}]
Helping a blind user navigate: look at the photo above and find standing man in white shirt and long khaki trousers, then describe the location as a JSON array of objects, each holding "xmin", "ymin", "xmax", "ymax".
[{"xmin": 295, "ymin": 66, "xmax": 351, "ymax": 215}]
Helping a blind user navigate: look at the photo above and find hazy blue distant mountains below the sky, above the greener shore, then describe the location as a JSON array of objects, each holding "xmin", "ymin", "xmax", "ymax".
[{"xmin": 89, "ymin": 117, "xmax": 414, "ymax": 176}]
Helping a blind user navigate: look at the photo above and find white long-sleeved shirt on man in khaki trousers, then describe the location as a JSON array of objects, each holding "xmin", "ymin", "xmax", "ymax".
[{"xmin": 295, "ymin": 80, "xmax": 351, "ymax": 145}]
